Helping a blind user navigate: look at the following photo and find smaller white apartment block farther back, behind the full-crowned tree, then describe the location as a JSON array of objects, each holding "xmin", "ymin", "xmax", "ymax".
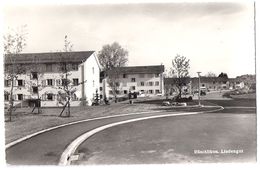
[{"xmin": 100, "ymin": 65, "xmax": 164, "ymax": 96}]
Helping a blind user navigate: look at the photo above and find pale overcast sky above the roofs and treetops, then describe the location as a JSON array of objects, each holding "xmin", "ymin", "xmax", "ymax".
[{"xmin": 3, "ymin": 2, "xmax": 255, "ymax": 77}]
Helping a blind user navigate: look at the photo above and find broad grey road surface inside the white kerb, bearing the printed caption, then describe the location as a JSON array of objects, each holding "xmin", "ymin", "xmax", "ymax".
[{"xmin": 73, "ymin": 113, "xmax": 256, "ymax": 165}]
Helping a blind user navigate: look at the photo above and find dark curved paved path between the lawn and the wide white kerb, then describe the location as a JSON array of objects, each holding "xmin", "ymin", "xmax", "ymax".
[{"xmin": 6, "ymin": 111, "xmax": 205, "ymax": 165}]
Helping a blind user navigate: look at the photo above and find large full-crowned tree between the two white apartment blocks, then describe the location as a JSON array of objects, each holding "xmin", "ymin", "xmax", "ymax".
[{"xmin": 98, "ymin": 42, "xmax": 128, "ymax": 102}]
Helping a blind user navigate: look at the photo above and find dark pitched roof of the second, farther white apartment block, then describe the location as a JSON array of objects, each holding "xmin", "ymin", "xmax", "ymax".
[{"xmin": 108, "ymin": 65, "xmax": 164, "ymax": 74}]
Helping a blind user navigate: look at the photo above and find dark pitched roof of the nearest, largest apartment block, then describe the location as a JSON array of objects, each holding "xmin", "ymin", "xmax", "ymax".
[{"xmin": 4, "ymin": 51, "xmax": 95, "ymax": 64}]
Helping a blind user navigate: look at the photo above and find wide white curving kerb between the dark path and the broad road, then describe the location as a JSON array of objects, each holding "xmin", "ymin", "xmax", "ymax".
[{"xmin": 59, "ymin": 106, "xmax": 224, "ymax": 165}]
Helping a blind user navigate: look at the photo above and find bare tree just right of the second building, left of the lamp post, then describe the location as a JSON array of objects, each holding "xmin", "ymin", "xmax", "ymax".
[{"xmin": 172, "ymin": 54, "xmax": 190, "ymax": 98}]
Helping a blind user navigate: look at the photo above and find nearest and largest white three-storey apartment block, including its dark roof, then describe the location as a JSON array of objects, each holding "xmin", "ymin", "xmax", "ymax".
[{"xmin": 4, "ymin": 51, "xmax": 100, "ymax": 107}]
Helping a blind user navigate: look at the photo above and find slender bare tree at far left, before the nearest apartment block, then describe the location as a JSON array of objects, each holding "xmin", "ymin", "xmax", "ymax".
[{"xmin": 4, "ymin": 25, "xmax": 27, "ymax": 121}]
